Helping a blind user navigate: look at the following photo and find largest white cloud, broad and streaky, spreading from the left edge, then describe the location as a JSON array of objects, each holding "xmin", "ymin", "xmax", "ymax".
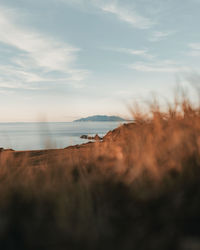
[{"xmin": 0, "ymin": 7, "xmax": 88, "ymax": 91}]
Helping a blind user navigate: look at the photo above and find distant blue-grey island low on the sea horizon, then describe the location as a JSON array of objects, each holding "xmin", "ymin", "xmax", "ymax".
[{"xmin": 74, "ymin": 115, "xmax": 126, "ymax": 122}]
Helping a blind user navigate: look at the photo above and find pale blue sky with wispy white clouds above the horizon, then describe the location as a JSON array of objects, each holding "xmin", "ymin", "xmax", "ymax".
[{"xmin": 0, "ymin": 0, "xmax": 200, "ymax": 122}]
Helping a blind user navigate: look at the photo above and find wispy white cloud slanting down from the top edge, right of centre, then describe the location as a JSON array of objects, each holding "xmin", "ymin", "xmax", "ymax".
[{"xmin": 98, "ymin": 1, "xmax": 154, "ymax": 29}]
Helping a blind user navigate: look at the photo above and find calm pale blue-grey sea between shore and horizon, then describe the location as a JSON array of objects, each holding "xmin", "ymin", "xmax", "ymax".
[{"xmin": 0, "ymin": 122, "xmax": 123, "ymax": 150}]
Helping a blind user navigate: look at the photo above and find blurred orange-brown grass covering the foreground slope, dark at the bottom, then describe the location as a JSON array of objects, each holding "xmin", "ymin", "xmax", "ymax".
[{"xmin": 0, "ymin": 98, "xmax": 200, "ymax": 250}]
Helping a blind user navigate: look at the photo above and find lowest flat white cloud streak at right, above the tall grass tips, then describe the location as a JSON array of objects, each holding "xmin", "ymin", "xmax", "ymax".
[{"xmin": 129, "ymin": 60, "xmax": 190, "ymax": 73}]
